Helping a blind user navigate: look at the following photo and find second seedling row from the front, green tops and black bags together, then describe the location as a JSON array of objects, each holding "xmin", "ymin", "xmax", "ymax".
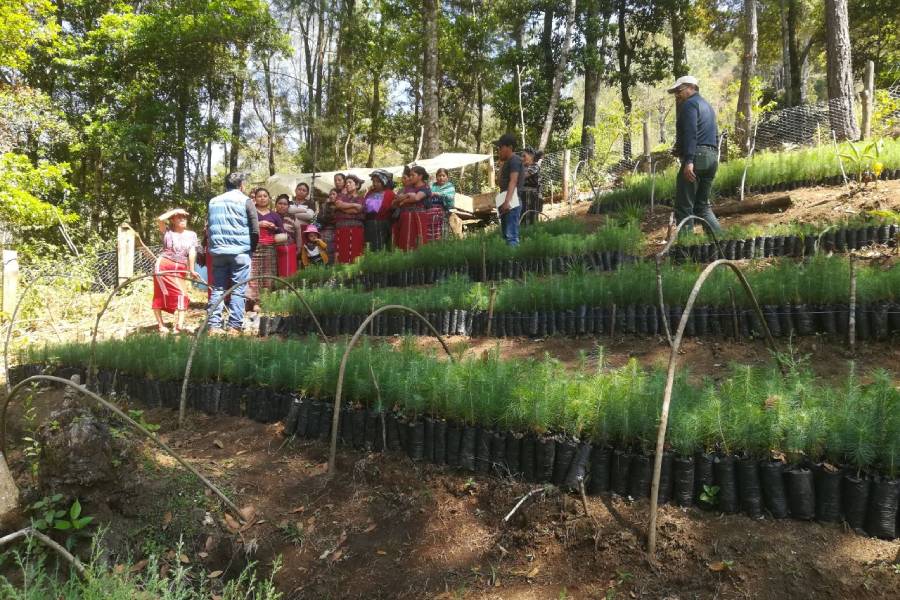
[{"xmin": 260, "ymin": 256, "xmax": 900, "ymax": 340}]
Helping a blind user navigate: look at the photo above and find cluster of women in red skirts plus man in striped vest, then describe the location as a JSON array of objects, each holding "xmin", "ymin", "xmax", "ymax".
[{"xmin": 153, "ymin": 165, "xmax": 456, "ymax": 333}]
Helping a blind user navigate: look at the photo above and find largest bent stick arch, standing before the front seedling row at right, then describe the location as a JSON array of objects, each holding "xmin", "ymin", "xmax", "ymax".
[{"xmin": 647, "ymin": 259, "xmax": 783, "ymax": 561}]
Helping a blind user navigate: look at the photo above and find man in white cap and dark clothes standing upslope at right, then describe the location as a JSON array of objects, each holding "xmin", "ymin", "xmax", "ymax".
[{"xmin": 667, "ymin": 75, "xmax": 722, "ymax": 233}]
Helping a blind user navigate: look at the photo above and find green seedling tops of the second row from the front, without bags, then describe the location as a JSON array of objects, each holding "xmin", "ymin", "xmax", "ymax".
[{"xmin": 261, "ymin": 255, "xmax": 900, "ymax": 316}]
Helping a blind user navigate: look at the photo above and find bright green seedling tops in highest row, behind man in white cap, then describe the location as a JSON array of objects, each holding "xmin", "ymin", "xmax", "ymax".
[{"xmin": 600, "ymin": 139, "xmax": 900, "ymax": 206}]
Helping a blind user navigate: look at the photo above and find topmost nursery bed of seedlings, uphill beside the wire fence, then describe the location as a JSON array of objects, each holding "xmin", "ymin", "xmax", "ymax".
[{"xmin": 591, "ymin": 139, "xmax": 900, "ymax": 212}]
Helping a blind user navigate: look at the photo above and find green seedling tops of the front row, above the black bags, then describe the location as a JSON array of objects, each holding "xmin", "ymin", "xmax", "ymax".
[{"xmin": 19, "ymin": 336, "xmax": 900, "ymax": 476}]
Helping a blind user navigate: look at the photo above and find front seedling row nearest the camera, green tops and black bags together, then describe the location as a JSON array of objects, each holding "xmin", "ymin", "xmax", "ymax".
[{"xmin": 13, "ymin": 336, "xmax": 900, "ymax": 539}]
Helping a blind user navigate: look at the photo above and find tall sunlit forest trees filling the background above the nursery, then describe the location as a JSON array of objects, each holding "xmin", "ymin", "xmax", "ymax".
[{"xmin": 0, "ymin": 0, "xmax": 900, "ymax": 253}]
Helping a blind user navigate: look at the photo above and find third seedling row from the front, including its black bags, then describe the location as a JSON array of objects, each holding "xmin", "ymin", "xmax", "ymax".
[{"xmin": 284, "ymin": 214, "xmax": 900, "ymax": 289}]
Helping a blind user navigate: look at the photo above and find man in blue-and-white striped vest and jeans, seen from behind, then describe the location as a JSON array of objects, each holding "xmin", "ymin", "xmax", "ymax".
[{"xmin": 206, "ymin": 173, "xmax": 259, "ymax": 335}]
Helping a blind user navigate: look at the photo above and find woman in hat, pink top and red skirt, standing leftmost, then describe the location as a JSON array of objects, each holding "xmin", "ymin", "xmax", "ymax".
[{"xmin": 153, "ymin": 208, "xmax": 198, "ymax": 333}]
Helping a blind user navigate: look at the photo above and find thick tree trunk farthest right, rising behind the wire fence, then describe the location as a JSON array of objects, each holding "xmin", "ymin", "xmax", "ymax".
[{"xmin": 825, "ymin": 0, "xmax": 859, "ymax": 140}]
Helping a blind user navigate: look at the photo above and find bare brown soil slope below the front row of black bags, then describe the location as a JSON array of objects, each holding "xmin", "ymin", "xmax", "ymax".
[{"xmin": 10, "ymin": 392, "xmax": 900, "ymax": 599}]
